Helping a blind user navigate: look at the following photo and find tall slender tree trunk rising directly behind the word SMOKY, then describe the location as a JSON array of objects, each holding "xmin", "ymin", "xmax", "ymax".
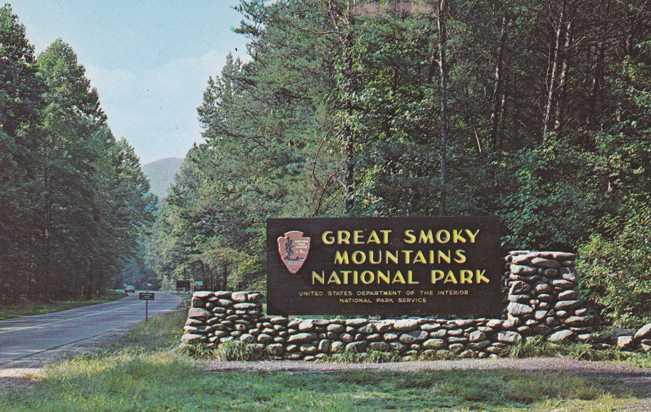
[{"xmin": 436, "ymin": 0, "xmax": 448, "ymax": 216}]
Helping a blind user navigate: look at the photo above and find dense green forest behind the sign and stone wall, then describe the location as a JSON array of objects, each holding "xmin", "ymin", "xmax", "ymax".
[{"xmin": 147, "ymin": 0, "xmax": 651, "ymax": 325}]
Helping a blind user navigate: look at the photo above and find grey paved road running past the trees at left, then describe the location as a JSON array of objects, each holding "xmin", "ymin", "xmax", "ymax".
[{"xmin": 0, "ymin": 292, "xmax": 181, "ymax": 369}]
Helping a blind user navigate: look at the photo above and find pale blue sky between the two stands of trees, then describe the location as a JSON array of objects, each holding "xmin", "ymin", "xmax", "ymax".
[{"xmin": 10, "ymin": 0, "xmax": 246, "ymax": 163}]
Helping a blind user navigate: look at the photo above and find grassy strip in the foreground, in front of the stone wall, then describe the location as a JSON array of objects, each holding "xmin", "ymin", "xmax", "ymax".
[{"xmin": 0, "ymin": 312, "xmax": 648, "ymax": 412}]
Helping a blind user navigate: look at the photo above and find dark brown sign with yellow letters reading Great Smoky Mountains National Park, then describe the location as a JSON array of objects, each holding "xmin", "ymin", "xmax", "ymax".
[{"xmin": 267, "ymin": 217, "xmax": 504, "ymax": 316}]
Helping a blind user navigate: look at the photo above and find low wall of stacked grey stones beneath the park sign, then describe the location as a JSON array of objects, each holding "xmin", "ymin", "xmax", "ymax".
[{"xmin": 182, "ymin": 251, "xmax": 616, "ymax": 360}]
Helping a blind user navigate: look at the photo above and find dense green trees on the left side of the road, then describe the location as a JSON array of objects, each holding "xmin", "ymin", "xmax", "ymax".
[{"xmin": 0, "ymin": 5, "xmax": 156, "ymax": 304}]
